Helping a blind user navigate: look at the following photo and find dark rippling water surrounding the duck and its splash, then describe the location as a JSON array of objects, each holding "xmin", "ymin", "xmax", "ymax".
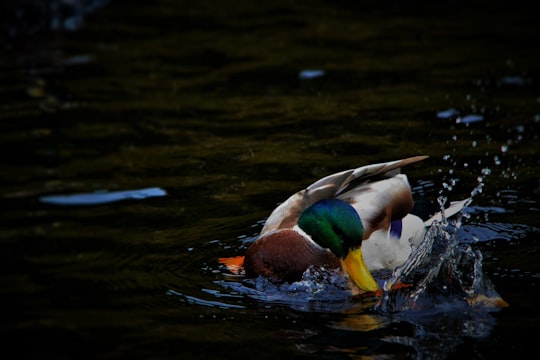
[{"xmin": 0, "ymin": 0, "xmax": 540, "ymax": 359}]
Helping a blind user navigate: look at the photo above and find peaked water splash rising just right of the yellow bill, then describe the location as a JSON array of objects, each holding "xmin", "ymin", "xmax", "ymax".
[{"xmin": 376, "ymin": 221, "xmax": 508, "ymax": 312}]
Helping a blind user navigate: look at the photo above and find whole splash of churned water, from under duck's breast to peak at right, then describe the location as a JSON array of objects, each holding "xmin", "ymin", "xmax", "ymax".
[{"xmin": 215, "ymin": 215, "xmax": 507, "ymax": 313}]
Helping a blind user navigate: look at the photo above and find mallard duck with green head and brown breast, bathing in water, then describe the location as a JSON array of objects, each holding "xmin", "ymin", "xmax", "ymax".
[{"xmin": 221, "ymin": 156, "xmax": 464, "ymax": 292}]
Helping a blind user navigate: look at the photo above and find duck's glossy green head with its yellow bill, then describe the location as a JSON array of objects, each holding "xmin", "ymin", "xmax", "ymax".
[{"xmin": 298, "ymin": 199, "xmax": 379, "ymax": 291}]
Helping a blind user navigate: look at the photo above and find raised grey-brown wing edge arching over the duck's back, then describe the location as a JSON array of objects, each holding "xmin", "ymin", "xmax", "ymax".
[{"xmin": 261, "ymin": 156, "xmax": 427, "ymax": 236}]
